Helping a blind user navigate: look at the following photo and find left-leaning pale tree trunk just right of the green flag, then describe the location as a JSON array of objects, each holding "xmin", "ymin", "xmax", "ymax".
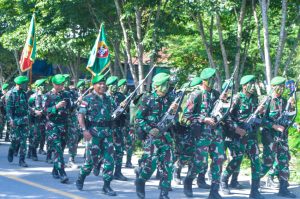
[{"xmin": 114, "ymin": 0, "xmax": 138, "ymax": 86}]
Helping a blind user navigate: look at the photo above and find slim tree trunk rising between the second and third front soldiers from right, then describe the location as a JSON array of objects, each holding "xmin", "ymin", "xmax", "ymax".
[{"xmin": 234, "ymin": 0, "xmax": 246, "ymax": 91}]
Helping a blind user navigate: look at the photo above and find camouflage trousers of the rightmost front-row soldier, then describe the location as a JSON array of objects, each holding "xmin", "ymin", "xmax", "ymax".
[{"xmin": 260, "ymin": 129, "xmax": 290, "ymax": 181}]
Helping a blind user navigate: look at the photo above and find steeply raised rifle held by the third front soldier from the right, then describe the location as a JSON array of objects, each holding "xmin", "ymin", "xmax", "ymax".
[{"xmin": 210, "ymin": 67, "xmax": 237, "ymax": 125}]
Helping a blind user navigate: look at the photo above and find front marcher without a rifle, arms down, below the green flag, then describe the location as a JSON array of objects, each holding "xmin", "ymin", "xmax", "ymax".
[{"xmin": 76, "ymin": 75, "xmax": 116, "ymax": 196}]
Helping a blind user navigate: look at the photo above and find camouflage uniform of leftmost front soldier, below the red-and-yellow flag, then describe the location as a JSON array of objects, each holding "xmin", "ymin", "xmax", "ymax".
[{"xmin": 6, "ymin": 87, "xmax": 29, "ymax": 165}]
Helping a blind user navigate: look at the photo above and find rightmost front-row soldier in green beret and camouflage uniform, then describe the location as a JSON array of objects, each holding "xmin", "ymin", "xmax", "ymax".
[{"xmin": 260, "ymin": 76, "xmax": 296, "ymax": 198}]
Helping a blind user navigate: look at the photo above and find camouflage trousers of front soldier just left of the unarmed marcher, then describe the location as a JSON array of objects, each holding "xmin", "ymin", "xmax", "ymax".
[{"xmin": 46, "ymin": 121, "xmax": 67, "ymax": 169}]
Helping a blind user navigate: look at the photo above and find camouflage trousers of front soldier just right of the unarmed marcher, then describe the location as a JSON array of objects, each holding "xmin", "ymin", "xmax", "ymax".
[{"xmin": 139, "ymin": 133, "xmax": 174, "ymax": 188}]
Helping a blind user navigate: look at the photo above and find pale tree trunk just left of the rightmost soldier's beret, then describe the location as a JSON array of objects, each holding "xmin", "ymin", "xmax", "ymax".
[{"xmin": 260, "ymin": 0, "xmax": 272, "ymax": 91}]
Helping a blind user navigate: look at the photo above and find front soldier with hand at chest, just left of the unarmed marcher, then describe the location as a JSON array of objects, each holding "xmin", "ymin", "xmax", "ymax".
[{"xmin": 43, "ymin": 74, "xmax": 69, "ymax": 183}]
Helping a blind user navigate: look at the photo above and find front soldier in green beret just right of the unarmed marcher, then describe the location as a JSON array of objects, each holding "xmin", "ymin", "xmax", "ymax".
[{"xmin": 135, "ymin": 73, "xmax": 176, "ymax": 199}]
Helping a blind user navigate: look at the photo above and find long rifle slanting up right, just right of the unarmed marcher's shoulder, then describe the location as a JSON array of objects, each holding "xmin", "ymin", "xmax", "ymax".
[{"xmin": 111, "ymin": 66, "xmax": 155, "ymax": 120}]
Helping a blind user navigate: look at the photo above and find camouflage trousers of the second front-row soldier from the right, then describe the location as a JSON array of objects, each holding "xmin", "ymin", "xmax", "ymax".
[{"xmin": 224, "ymin": 133, "xmax": 260, "ymax": 180}]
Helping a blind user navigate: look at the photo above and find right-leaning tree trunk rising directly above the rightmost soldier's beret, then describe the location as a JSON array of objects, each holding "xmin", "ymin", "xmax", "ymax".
[{"xmin": 274, "ymin": 0, "xmax": 287, "ymax": 76}]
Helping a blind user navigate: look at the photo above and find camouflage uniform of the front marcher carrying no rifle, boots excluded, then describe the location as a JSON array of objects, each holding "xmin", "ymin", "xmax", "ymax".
[{"xmin": 79, "ymin": 92, "xmax": 114, "ymax": 182}]
